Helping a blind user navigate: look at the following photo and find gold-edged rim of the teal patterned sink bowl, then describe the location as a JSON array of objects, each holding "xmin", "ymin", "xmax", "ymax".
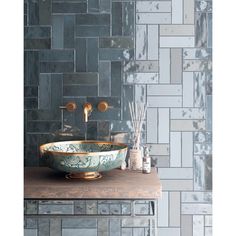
[{"xmin": 39, "ymin": 140, "xmax": 128, "ymax": 156}]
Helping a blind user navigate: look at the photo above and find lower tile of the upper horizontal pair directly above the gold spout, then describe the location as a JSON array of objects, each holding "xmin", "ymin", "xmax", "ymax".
[{"xmin": 75, "ymin": 25, "xmax": 110, "ymax": 37}]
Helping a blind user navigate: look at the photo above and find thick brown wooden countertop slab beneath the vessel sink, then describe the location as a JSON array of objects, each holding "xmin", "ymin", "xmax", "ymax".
[{"xmin": 24, "ymin": 167, "xmax": 161, "ymax": 199}]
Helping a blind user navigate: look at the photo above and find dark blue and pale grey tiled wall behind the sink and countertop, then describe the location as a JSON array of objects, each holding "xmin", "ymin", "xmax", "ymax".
[{"xmin": 24, "ymin": 0, "xmax": 212, "ymax": 236}]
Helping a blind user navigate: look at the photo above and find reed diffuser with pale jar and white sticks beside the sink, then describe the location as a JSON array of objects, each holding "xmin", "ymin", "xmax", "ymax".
[{"xmin": 129, "ymin": 102, "xmax": 147, "ymax": 170}]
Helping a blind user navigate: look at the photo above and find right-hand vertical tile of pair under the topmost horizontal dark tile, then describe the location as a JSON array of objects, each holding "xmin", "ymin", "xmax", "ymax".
[{"xmin": 63, "ymin": 15, "xmax": 75, "ymax": 48}]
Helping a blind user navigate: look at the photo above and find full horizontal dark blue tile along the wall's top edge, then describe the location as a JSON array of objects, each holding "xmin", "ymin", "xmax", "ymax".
[{"xmin": 52, "ymin": 2, "xmax": 87, "ymax": 13}]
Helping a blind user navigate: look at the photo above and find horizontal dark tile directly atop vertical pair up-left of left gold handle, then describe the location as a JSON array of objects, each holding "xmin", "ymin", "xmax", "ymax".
[{"xmin": 40, "ymin": 61, "xmax": 74, "ymax": 73}]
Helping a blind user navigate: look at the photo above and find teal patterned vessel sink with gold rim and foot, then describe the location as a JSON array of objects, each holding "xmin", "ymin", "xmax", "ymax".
[{"xmin": 40, "ymin": 141, "xmax": 128, "ymax": 180}]
